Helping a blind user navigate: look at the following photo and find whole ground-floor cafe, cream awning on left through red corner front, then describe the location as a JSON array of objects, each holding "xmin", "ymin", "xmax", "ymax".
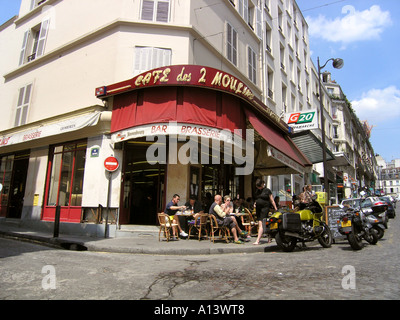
[{"xmin": 0, "ymin": 65, "xmax": 312, "ymax": 236}]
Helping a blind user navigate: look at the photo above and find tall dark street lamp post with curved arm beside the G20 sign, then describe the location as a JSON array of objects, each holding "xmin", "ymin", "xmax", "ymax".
[{"xmin": 318, "ymin": 57, "xmax": 344, "ymax": 204}]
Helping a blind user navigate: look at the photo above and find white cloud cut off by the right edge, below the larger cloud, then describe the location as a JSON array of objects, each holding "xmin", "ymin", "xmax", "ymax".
[{"xmin": 351, "ymin": 86, "xmax": 400, "ymax": 125}]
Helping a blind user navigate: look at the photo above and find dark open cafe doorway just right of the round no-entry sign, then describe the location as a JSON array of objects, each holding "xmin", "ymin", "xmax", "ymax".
[{"xmin": 119, "ymin": 141, "xmax": 166, "ymax": 225}]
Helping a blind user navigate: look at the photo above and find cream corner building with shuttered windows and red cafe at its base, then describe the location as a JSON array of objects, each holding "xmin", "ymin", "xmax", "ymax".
[{"xmin": 0, "ymin": 0, "xmax": 340, "ymax": 235}]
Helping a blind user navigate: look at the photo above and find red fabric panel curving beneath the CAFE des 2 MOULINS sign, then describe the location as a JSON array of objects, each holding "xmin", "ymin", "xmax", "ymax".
[{"xmin": 111, "ymin": 87, "xmax": 245, "ymax": 133}]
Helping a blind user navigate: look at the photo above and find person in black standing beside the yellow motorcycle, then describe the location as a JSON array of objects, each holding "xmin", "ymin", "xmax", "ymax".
[{"xmin": 253, "ymin": 179, "xmax": 278, "ymax": 245}]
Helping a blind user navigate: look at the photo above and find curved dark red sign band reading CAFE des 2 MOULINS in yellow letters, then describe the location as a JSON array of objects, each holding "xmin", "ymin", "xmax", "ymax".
[{"xmin": 96, "ymin": 65, "xmax": 289, "ymax": 132}]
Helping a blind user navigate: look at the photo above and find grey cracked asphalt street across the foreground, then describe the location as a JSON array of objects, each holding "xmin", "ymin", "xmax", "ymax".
[{"xmin": 0, "ymin": 209, "xmax": 400, "ymax": 302}]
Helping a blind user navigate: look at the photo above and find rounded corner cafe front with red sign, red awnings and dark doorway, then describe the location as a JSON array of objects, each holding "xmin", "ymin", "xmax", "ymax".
[{"xmin": 96, "ymin": 65, "xmax": 311, "ymax": 225}]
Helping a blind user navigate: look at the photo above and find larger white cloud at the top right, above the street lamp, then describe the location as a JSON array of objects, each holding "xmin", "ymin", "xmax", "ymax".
[{"xmin": 306, "ymin": 5, "xmax": 392, "ymax": 44}]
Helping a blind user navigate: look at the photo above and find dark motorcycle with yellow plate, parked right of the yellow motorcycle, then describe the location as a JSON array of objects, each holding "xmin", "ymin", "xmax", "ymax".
[{"xmin": 338, "ymin": 208, "xmax": 379, "ymax": 250}]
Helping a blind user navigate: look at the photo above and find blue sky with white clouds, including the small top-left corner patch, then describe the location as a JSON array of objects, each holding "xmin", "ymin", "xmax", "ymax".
[{"xmin": 0, "ymin": 0, "xmax": 400, "ymax": 161}]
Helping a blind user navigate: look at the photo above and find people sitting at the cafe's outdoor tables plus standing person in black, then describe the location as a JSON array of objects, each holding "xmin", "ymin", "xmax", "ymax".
[{"xmin": 165, "ymin": 179, "xmax": 286, "ymax": 245}]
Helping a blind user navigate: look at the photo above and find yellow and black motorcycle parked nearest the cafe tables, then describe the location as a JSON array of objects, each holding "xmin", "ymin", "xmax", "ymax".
[{"xmin": 265, "ymin": 197, "xmax": 333, "ymax": 252}]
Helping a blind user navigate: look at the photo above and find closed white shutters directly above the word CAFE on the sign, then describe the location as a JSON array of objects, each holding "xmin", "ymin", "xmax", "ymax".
[{"xmin": 134, "ymin": 47, "xmax": 172, "ymax": 75}]
